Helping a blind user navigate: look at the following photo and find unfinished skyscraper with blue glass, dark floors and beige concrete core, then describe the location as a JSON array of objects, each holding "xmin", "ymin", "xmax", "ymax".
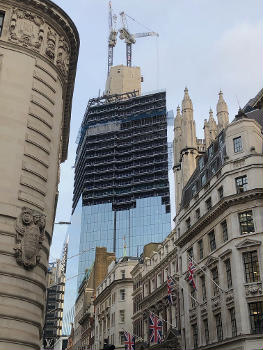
[{"xmin": 73, "ymin": 66, "xmax": 170, "ymax": 284}]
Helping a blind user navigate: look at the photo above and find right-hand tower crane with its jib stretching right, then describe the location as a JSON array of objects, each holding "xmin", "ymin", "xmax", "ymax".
[{"xmin": 119, "ymin": 11, "xmax": 159, "ymax": 67}]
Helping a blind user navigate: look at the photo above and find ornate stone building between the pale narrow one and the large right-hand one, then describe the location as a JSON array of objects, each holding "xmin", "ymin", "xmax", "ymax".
[{"xmin": 131, "ymin": 231, "xmax": 180, "ymax": 350}]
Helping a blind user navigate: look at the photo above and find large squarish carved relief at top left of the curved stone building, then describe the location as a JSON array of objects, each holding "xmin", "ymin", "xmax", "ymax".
[{"xmin": 9, "ymin": 8, "xmax": 45, "ymax": 51}]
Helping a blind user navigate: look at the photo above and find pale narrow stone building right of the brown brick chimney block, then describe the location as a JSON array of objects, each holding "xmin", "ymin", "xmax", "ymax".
[{"xmin": 92, "ymin": 256, "xmax": 138, "ymax": 350}]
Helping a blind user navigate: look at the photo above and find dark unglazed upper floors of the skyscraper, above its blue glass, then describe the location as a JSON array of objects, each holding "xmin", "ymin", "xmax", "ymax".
[{"xmin": 73, "ymin": 91, "xmax": 170, "ymax": 212}]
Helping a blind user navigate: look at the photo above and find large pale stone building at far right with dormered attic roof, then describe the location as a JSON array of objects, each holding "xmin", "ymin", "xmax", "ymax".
[{"xmin": 175, "ymin": 91, "xmax": 263, "ymax": 350}]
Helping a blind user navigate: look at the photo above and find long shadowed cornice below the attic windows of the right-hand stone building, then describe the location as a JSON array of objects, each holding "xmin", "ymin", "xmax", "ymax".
[{"xmin": 174, "ymin": 188, "xmax": 263, "ymax": 248}]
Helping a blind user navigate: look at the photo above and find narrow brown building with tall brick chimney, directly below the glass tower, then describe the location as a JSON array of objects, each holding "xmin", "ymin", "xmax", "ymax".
[{"xmin": 72, "ymin": 247, "xmax": 115, "ymax": 350}]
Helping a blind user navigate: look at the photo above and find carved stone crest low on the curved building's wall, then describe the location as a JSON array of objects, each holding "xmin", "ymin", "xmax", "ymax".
[{"xmin": 14, "ymin": 207, "xmax": 46, "ymax": 269}]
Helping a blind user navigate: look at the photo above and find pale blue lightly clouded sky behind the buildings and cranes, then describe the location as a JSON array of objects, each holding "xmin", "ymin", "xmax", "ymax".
[{"xmin": 50, "ymin": 0, "xmax": 263, "ymax": 260}]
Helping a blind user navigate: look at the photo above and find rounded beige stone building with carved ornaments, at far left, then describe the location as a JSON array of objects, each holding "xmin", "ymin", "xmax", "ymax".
[{"xmin": 0, "ymin": 0, "xmax": 79, "ymax": 350}]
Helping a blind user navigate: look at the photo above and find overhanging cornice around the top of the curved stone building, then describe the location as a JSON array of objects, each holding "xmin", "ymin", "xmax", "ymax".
[{"xmin": 0, "ymin": 0, "xmax": 80, "ymax": 162}]
